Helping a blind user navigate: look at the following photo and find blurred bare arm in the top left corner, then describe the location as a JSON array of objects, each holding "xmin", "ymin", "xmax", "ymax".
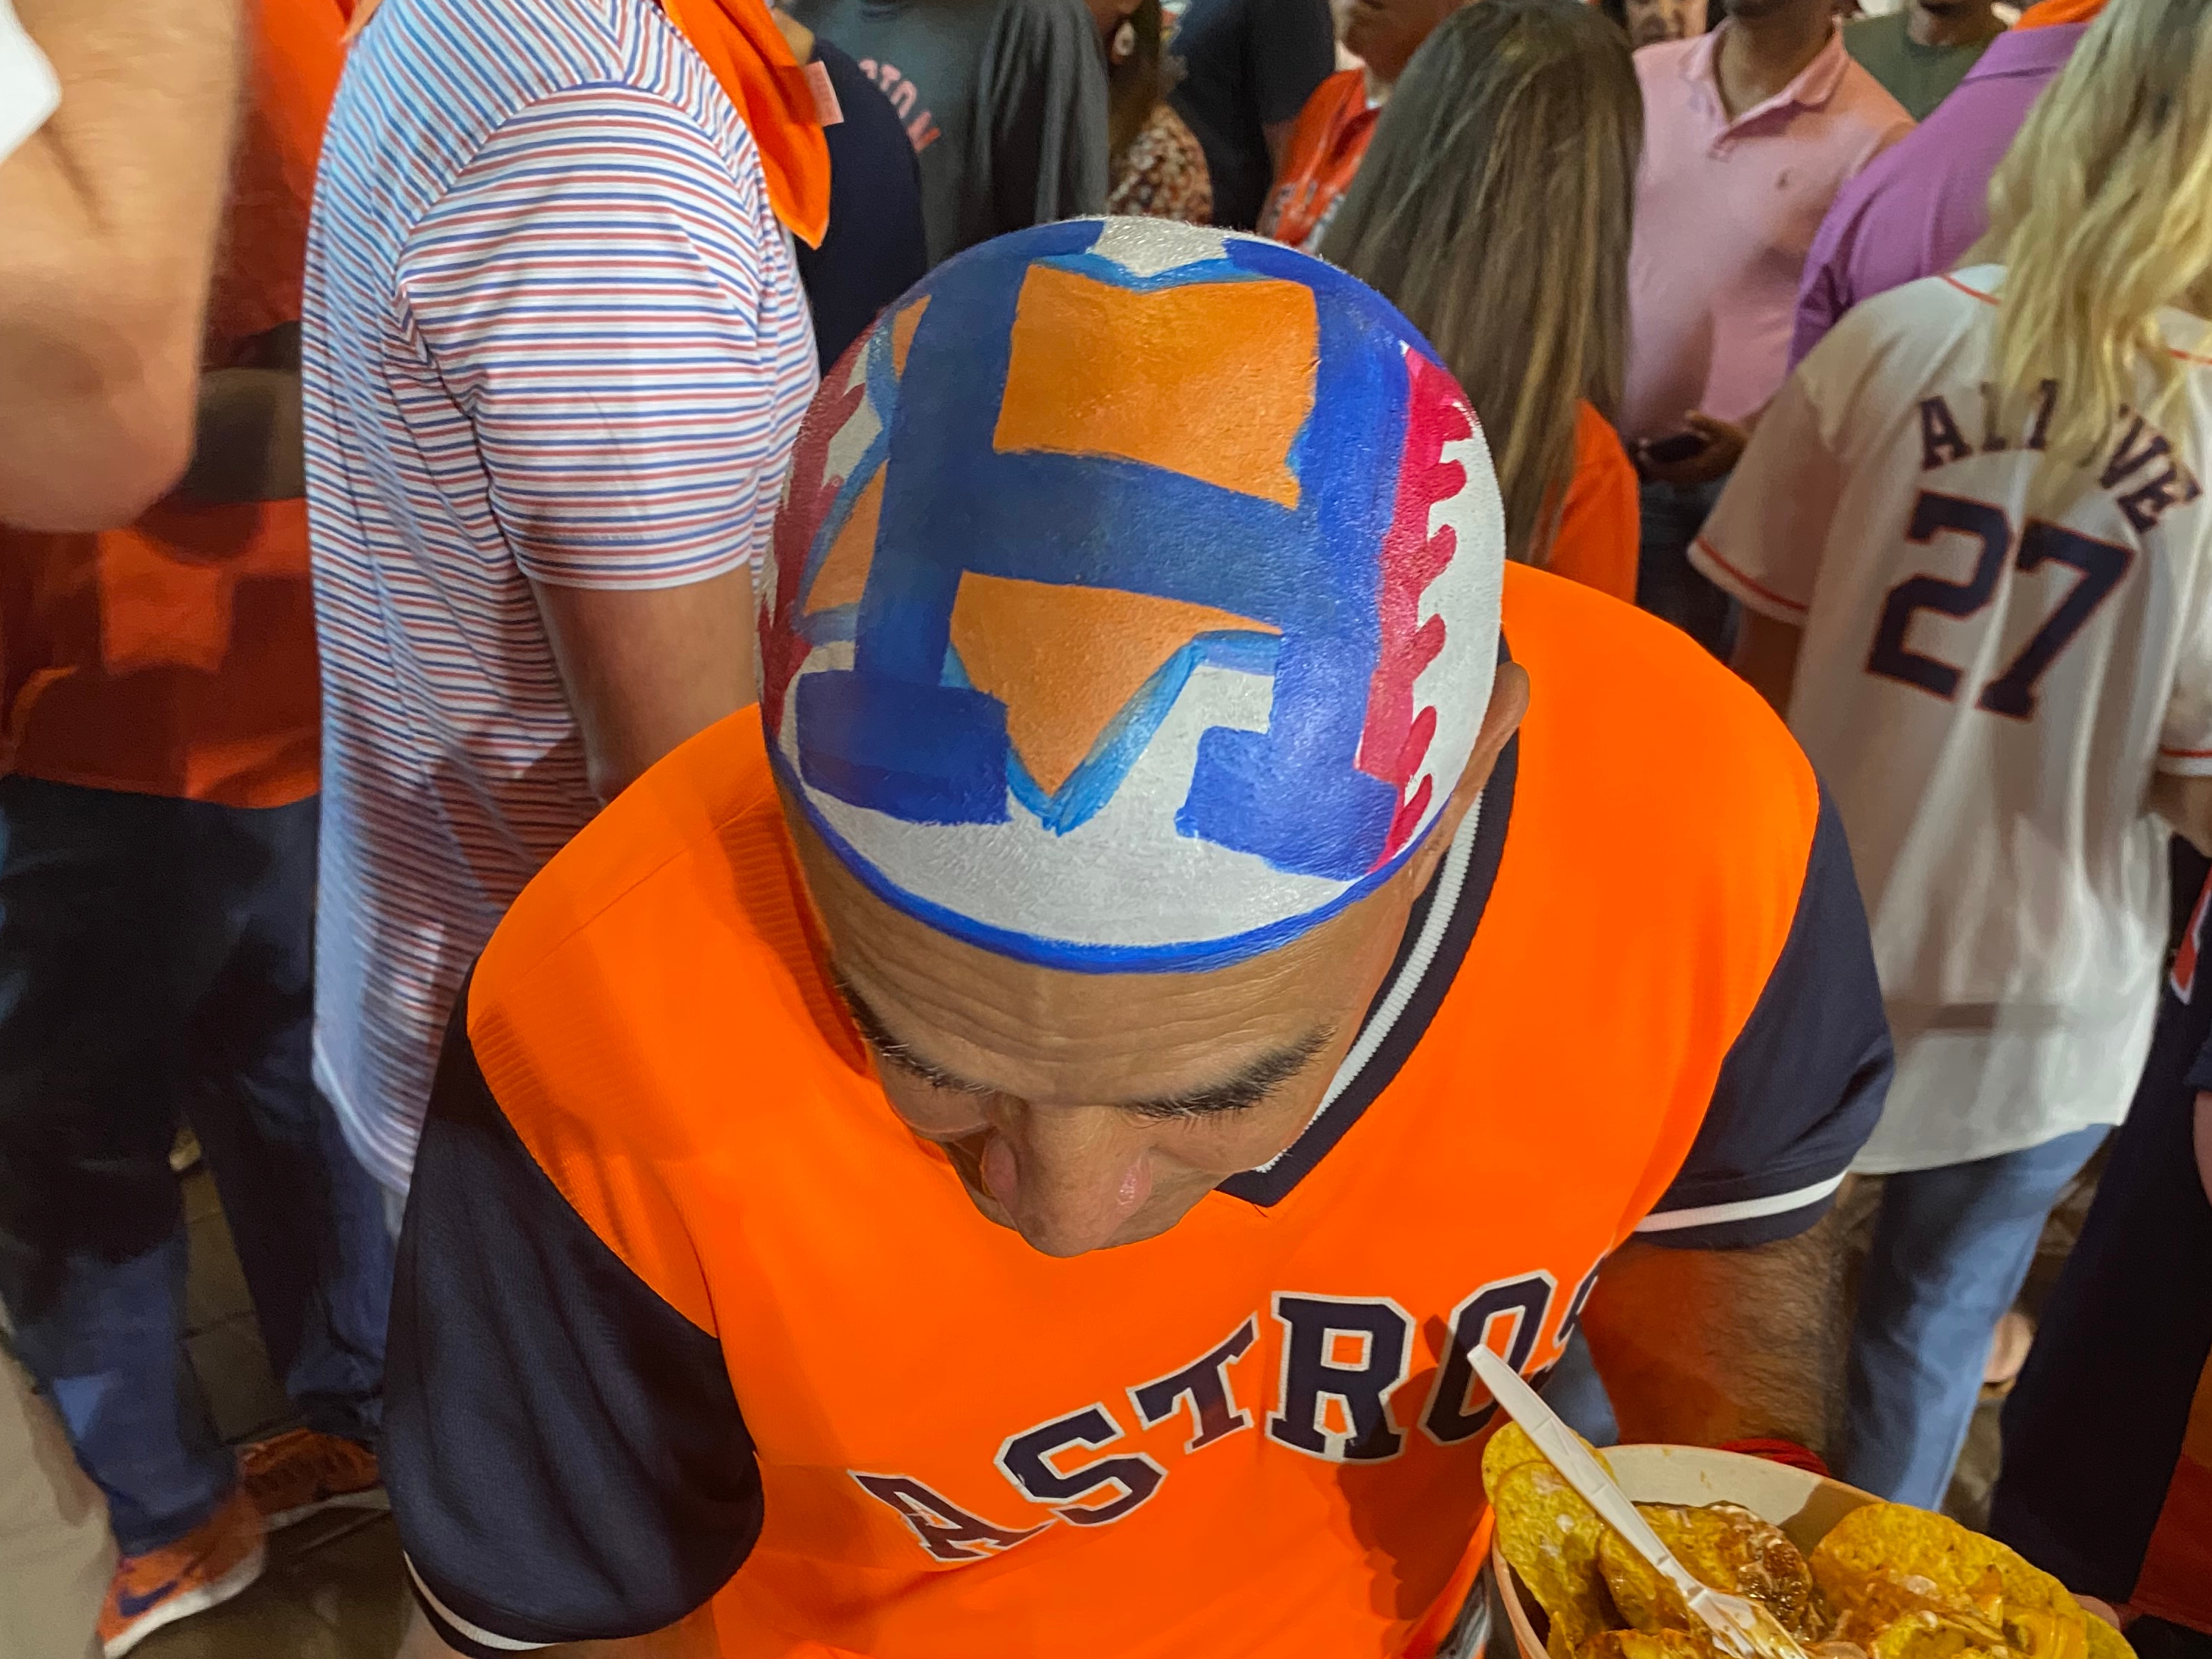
[{"xmin": 0, "ymin": 0, "xmax": 239, "ymax": 531}]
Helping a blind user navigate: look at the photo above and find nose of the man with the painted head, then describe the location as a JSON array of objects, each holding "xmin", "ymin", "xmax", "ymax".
[{"xmin": 982, "ymin": 1106, "xmax": 1153, "ymax": 1257}]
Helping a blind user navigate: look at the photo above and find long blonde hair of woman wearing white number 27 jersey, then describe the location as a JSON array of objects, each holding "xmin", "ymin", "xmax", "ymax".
[{"xmin": 1969, "ymin": 0, "xmax": 2212, "ymax": 455}]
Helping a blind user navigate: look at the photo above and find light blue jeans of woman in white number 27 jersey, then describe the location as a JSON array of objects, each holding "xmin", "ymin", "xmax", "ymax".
[{"xmin": 1836, "ymin": 1128, "xmax": 2108, "ymax": 1509}]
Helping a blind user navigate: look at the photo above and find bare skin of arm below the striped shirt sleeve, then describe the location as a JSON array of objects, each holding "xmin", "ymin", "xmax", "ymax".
[{"xmin": 531, "ymin": 566, "xmax": 752, "ymax": 800}]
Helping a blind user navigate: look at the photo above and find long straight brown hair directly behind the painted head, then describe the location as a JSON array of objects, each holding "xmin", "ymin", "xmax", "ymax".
[{"xmin": 1320, "ymin": 0, "xmax": 1643, "ymax": 564}]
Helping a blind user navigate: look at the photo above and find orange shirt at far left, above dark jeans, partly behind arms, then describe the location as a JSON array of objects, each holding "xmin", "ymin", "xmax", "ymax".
[{"xmin": 0, "ymin": 0, "xmax": 345, "ymax": 807}]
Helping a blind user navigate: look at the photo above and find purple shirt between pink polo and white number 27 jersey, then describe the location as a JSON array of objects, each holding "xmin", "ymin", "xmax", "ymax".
[{"xmin": 1790, "ymin": 22, "xmax": 2088, "ymax": 367}]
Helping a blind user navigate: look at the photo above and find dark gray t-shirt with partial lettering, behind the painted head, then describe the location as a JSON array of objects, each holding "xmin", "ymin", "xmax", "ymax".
[{"xmin": 789, "ymin": 0, "xmax": 1106, "ymax": 266}]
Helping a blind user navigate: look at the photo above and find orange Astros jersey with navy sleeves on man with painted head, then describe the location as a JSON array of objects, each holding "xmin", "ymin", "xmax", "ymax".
[{"xmin": 385, "ymin": 569, "xmax": 1889, "ymax": 1659}]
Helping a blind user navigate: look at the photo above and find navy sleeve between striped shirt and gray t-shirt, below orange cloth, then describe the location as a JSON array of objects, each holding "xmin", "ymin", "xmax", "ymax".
[{"xmin": 799, "ymin": 38, "xmax": 929, "ymax": 374}]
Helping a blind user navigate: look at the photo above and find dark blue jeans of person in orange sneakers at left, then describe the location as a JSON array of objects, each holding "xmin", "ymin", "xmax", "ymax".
[{"xmin": 0, "ymin": 778, "xmax": 391, "ymax": 1555}]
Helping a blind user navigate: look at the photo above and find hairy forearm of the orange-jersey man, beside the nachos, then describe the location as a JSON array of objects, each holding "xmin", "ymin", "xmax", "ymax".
[{"xmin": 1584, "ymin": 1212, "xmax": 1843, "ymax": 1451}]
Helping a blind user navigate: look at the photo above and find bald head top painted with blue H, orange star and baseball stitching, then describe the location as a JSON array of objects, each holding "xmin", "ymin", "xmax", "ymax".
[{"xmin": 761, "ymin": 219, "xmax": 1504, "ymax": 971}]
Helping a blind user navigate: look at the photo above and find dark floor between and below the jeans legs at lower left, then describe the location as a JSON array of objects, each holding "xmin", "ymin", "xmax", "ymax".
[{"xmin": 132, "ymin": 1170, "xmax": 409, "ymax": 1659}]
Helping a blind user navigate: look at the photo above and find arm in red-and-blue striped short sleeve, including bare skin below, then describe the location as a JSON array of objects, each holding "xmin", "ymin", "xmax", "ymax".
[{"xmin": 400, "ymin": 88, "xmax": 814, "ymax": 798}]
